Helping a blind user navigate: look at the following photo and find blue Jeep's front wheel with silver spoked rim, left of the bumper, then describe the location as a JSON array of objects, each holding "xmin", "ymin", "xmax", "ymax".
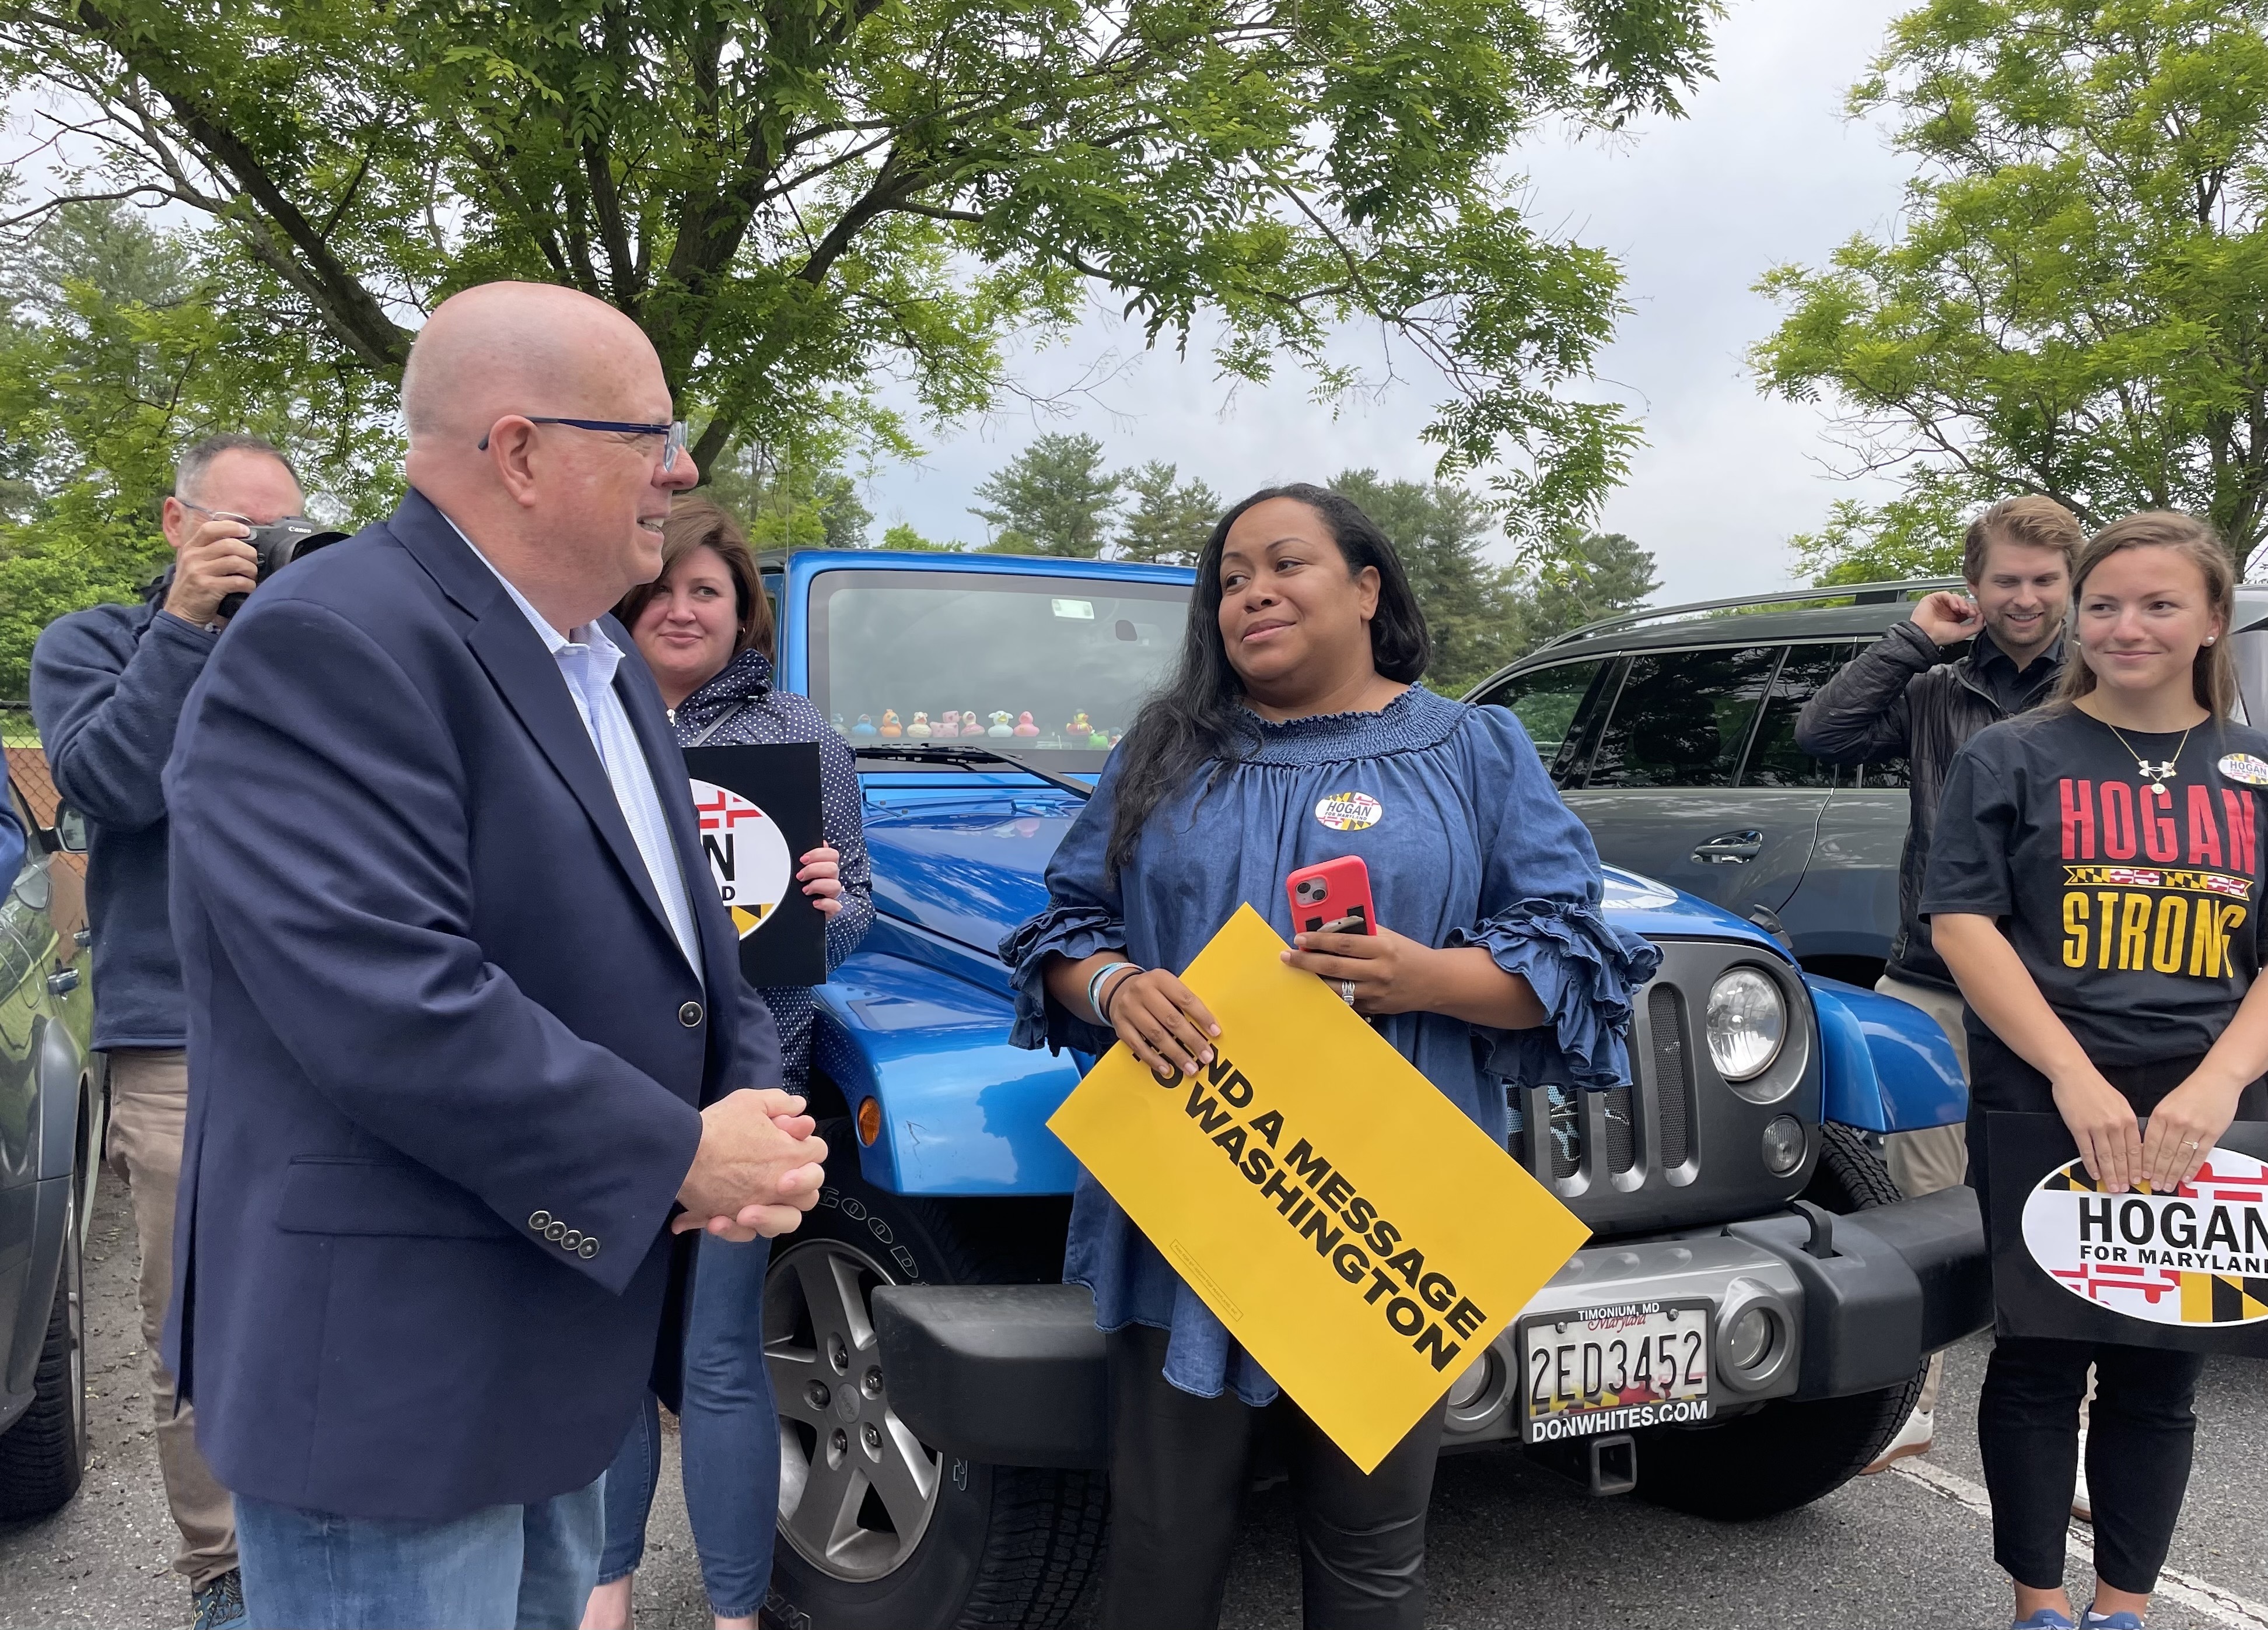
[{"xmin": 764, "ymin": 1120, "xmax": 1104, "ymax": 1630}]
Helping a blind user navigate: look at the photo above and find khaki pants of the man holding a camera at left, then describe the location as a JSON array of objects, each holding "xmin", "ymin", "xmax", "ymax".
[{"xmin": 109, "ymin": 1050, "xmax": 236, "ymax": 1589}]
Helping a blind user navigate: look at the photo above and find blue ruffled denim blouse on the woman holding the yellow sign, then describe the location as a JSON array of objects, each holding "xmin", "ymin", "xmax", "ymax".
[{"xmin": 1000, "ymin": 687, "xmax": 1660, "ymax": 1408}]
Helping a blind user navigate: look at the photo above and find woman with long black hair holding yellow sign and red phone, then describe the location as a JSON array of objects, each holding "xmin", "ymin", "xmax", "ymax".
[{"xmin": 1002, "ymin": 485, "xmax": 1658, "ymax": 1630}]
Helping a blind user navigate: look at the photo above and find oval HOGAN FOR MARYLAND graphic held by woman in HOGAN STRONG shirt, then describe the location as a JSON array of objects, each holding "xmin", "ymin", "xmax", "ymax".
[{"xmin": 2023, "ymin": 1149, "xmax": 2268, "ymax": 1326}]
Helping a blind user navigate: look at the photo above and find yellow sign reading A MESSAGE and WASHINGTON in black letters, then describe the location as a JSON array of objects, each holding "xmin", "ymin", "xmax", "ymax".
[{"xmin": 1048, "ymin": 905, "xmax": 1590, "ymax": 1471}]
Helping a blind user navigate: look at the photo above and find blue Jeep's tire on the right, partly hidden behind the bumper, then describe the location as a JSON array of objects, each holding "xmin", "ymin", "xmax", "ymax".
[{"xmin": 1637, "ymin": 1122, "xmax": 1928, "ymax": 1521}]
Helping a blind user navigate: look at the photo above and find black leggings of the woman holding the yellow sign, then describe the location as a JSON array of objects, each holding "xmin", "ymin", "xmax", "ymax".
[{"xmin": 1102, "ymin": 1324, "xmax": 1440, "ymax": 1630}]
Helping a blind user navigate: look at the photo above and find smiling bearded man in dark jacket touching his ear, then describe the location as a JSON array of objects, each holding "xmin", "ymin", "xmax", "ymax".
[{"xmin": 1796, "ymin": 496, "xmax": 2082, "ymax": 1471}]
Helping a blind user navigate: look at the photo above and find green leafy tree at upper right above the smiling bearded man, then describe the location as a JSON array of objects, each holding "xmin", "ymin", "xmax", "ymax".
[{"xmin": 1753, "ymin": 0, "xmax": 2268, "ymax": 580}]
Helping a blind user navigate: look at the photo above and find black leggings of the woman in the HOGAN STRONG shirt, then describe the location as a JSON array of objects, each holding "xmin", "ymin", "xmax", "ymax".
[{"xmin": 1969, "ymin": 1034, "xmax": 2261, "ymax": 1594}]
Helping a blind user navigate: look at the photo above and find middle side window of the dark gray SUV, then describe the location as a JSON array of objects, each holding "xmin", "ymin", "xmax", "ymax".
[{"xmin": 1581, "ymin": 646, "xmax": 1780, "ymax": 787}]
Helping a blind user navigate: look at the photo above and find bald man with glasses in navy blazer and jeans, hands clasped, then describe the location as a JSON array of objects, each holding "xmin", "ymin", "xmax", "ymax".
[{"xmin": 168, "ymin": 283, "xmax": 825, "ymax": 1630}]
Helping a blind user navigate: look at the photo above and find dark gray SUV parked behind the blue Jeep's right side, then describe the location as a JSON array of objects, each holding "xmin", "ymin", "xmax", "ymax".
[{"xmin": 1465, "ymin": 578, "xmax": 2268, "ymax": 986}]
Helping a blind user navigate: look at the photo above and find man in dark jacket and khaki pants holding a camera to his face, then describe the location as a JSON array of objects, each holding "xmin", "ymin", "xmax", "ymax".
[{"xmin": 32, "ymin": 435, "xmax": 322, "ymax": 1630}]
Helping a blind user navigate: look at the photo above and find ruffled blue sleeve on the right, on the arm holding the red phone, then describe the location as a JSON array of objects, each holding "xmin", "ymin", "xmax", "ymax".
[{"xmin": 1449, "ymin": 707, "xmax": 1662, "ymax": 1091}]
